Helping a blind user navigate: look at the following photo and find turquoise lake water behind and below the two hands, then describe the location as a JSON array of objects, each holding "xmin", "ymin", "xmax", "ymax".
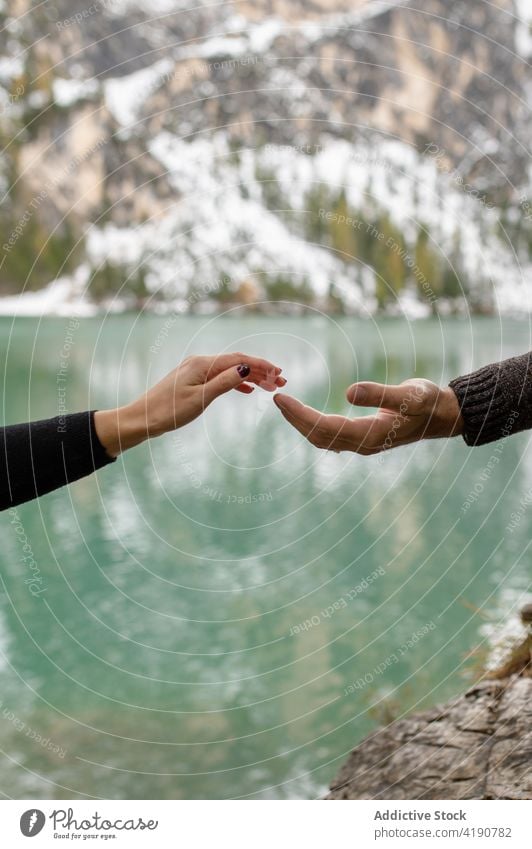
[{"xmin": 0, "ymin": 313, "xmax": 532, "ymax": 799}]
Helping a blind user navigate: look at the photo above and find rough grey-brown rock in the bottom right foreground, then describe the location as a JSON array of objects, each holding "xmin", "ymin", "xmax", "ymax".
[{"xmin": 326, "ymin": 675, "xmax": 532, "ymax": 799}]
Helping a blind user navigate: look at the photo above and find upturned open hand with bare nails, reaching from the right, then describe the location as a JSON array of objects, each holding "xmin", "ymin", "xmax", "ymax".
[{"xmin": 274, "ymin": 379, "xmax": 463, "ymax": 454}]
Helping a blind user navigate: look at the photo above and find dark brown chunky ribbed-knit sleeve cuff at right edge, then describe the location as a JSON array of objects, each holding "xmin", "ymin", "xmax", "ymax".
[{"xmin": 449, "ymin": 351, "xmax": 532, "ymax": 445}]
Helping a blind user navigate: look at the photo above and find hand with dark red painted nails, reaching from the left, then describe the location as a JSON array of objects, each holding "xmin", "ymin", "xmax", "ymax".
[{"xmin": 94, "ymin": 353, "xmax": 286, "ymax": 457}]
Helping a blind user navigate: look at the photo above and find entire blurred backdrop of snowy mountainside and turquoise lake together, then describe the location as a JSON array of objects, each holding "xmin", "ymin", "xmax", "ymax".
[{"xmin": 0, "ymin": 0, "xmax": 532, "ymax": 799}]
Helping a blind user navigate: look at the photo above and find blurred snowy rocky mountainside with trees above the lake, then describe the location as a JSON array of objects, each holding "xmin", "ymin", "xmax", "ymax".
[{"xmin": 0, "ymin": 0, "xmax": 532, "ymax": 313}]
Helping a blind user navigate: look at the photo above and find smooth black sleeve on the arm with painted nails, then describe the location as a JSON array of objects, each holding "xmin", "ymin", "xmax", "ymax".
[{"xmin": 0, "ymin": 410, "xmax": 116, "ymax": 510}]
